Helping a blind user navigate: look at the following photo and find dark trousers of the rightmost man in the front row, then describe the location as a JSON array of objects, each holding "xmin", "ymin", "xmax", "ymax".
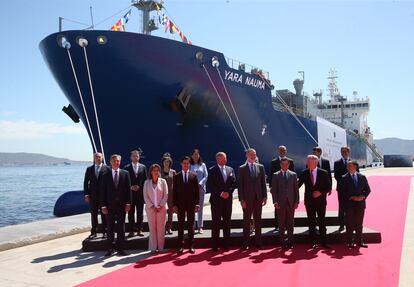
[{"xmin": 346, "ymin": 205, "xmax": 365, "ymax": 244}]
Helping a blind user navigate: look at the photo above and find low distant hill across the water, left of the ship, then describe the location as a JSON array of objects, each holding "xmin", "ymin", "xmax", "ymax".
[{"xmin": 0, "ymin": 152, "xmax": 86, "ymax": 166}]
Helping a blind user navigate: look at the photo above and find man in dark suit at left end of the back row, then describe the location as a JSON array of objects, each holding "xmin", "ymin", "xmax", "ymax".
[{"xmin": 83, "ymin": 152, "xmax": 109, "ymax": 239}]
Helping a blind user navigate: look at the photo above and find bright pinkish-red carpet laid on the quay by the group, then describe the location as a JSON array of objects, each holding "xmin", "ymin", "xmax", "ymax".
[{"xmin": 79, "ymin": 177, "xmax": 411, "ymax": 287}]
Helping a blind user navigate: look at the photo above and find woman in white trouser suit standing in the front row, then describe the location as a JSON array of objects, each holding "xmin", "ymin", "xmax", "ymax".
[{"xmin": 144, "ymin": 164, "xmax": 168, "ymax": 252}]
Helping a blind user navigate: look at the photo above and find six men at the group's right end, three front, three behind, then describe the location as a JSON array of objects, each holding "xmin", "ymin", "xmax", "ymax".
[{"xmin": 269, "ymin": 146, "xmax": 371, "ymax": 249}]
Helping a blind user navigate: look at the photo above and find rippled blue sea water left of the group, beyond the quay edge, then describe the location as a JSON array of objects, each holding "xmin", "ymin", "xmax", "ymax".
[{"xmin": 0, "ymin": 164, "xmax": 87, "ymax": 230}]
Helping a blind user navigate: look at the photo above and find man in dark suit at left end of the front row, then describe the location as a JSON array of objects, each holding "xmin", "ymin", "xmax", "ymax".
[{"xmin": 100, "ymin": 154, "xmax": 131, "ymax": 256}]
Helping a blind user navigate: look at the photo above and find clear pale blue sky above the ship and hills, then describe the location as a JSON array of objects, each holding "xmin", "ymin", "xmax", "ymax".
[{"xmin": 0, "ymin": 0, "xmax": 414, "ymax": 160}]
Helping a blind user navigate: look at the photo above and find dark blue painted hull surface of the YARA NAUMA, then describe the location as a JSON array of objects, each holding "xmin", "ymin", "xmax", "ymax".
[{"xmin": 40, "ymin": 31, "xmax": 366, "ymax": 174}]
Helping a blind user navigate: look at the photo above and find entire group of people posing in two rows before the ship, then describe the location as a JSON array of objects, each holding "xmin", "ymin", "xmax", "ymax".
[{"xmin": 84, "ymin": 146, "xmax": 370, "ymax": 256}]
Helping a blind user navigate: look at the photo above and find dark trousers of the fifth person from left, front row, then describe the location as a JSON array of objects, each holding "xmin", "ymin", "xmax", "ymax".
[{"xmin": 243, "ymin": 200, "xmax": 262, "ymax": 246}]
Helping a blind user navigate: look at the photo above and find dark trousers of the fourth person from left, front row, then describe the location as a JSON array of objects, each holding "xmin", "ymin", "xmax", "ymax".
[{"xmin": 210, "ymin": 199, "xmax": 233, "ymax": 248}]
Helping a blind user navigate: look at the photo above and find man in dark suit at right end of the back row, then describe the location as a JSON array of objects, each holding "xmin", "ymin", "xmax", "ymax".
[{"xmin": 334, "ymin": 146, "xmax": 359, "ymax": 231}]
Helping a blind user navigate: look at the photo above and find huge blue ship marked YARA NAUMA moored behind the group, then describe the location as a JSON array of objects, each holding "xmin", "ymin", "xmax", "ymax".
[{"xmin": 40, "ymin": 0, "xmax": 378, "ymax": 176}]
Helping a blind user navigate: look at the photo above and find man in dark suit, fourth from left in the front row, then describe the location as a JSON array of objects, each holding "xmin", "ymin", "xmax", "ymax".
[{"xmin": 207, "ymin": 152, "xmax": 237, "ymax": 251}]
